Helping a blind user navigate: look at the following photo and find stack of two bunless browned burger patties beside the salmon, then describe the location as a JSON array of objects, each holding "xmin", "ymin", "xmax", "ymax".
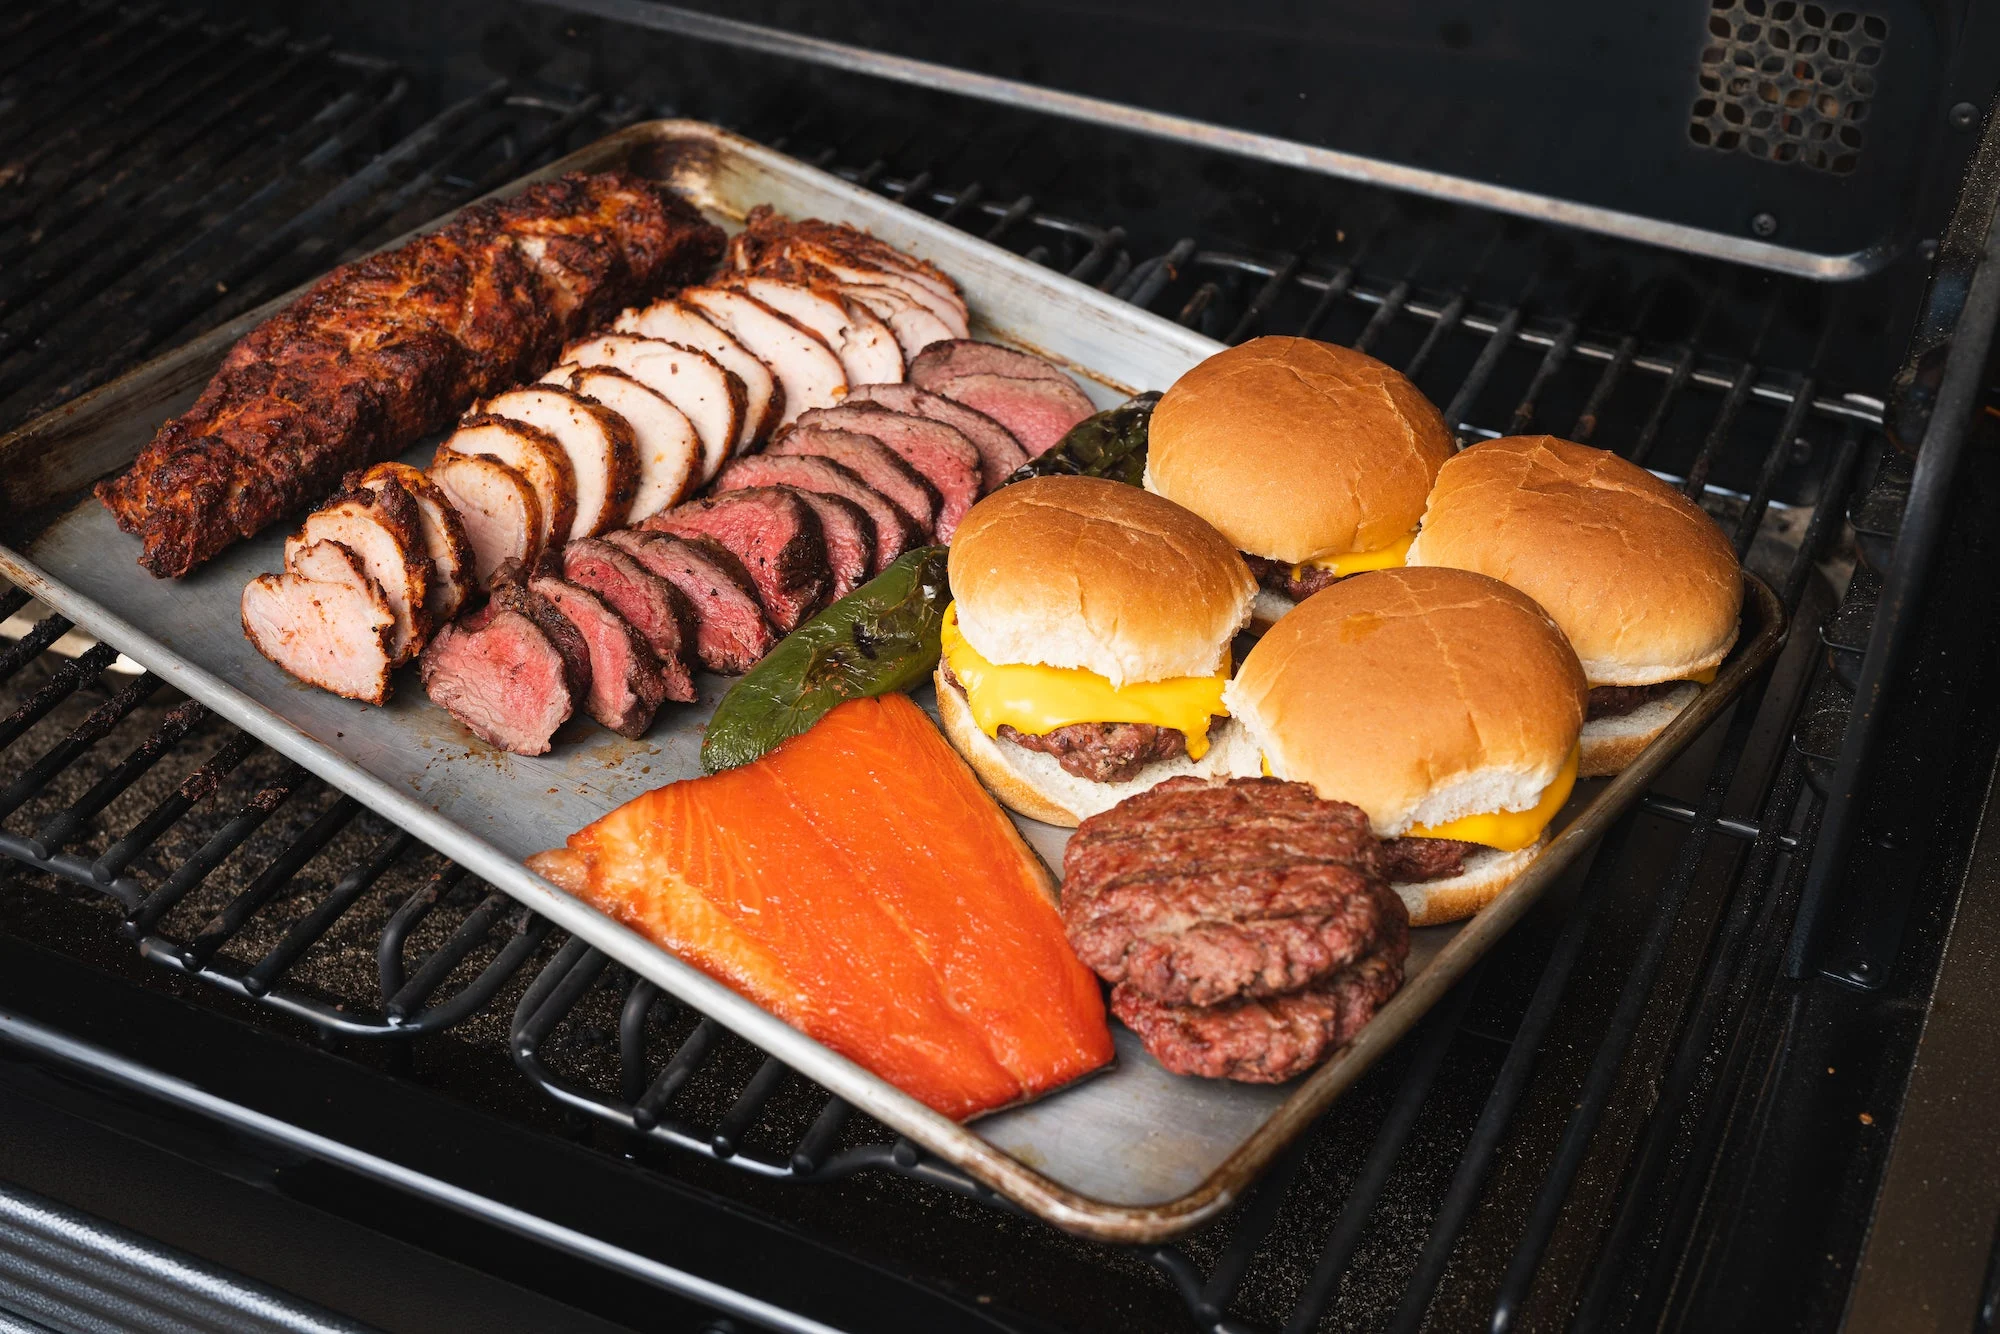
[{"xmin": 1062, "ymin": 778, "xmax": 1410, "ymax": 1084}]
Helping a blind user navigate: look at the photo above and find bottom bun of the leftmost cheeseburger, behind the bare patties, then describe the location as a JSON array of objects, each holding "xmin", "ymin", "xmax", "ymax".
[{"xmin": 932, "ymin": 664, "xmax": 1258, "ymax": 830}]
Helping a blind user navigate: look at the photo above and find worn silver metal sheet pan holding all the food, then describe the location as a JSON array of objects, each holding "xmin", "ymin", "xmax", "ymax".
[{"xmin": 0, "ymin": 120, "xmax": 1784, "ymax": 1242}]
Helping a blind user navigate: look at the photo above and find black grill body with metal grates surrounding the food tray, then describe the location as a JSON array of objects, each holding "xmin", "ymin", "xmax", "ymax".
[{"xmin": 0, "ymin": 0, "xmax": 2000, "ymax": 1330}]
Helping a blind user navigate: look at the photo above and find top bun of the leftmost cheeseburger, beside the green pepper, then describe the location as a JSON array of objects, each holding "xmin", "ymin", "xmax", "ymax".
[{"xmin": 950, "ymin": 476, "xmax": 1256, "ymax": 686}]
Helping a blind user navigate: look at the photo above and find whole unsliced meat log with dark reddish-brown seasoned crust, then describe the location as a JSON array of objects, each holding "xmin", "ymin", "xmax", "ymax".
[{"xmin": 98, "ymin": 172, "xmax": 722, "ymax": 576}]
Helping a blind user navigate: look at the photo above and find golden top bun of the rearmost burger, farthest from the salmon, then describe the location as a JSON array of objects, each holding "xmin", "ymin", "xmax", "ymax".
[{"xmin": 1146, "ymin": 338, "xmax": 1452, "ymax": 562}]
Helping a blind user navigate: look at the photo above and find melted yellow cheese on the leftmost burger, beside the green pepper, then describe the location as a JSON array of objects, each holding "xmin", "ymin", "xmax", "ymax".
[{"xmin": 940, "ymin": 606, "xmax": 1230, "ymax": 760}]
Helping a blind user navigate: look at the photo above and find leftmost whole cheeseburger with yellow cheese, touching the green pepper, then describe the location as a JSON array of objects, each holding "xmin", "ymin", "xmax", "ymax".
[{"xmin": 936, "ymin": 476, "xmax": 1256, "ymax": 826}]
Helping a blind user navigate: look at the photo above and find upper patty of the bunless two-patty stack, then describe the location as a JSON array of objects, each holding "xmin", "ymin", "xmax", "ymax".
[{"xmin": 1062, "ymin": 778, "xmax": 1410, "ymax": 1006}]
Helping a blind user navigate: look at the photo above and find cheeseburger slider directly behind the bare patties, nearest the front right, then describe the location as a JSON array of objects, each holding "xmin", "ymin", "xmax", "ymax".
[{"xmin": 1222, "ymin": 570, "xmax": 1586, "ymax": 926}]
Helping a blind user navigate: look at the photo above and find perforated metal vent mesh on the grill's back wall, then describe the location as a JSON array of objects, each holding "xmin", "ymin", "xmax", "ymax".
[{"xmin": 1688, "ymin": 0, "xmax": 1888, "ymax": 174}]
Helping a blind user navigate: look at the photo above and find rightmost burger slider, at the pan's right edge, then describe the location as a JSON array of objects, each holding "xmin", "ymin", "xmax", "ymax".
[{"xmin": 1410, "ymin": 436, "xmax": 1744, "ymax": 778}]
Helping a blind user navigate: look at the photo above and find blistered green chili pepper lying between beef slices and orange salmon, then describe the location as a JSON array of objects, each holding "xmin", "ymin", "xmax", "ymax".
[{"xmin": 702, "ymin": 546, "xmax": 950, "ymax": 774}]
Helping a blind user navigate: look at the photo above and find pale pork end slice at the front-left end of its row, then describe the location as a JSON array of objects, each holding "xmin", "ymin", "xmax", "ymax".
[{"xmin": 242, "ymin": 542, "xmax": 396, "ymax": 704}]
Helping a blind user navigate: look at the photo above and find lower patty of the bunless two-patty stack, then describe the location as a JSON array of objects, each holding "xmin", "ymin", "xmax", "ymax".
[{"xmin": 1112, "ymin": 956, "xmax": 1402, "ymax": 1084}]
